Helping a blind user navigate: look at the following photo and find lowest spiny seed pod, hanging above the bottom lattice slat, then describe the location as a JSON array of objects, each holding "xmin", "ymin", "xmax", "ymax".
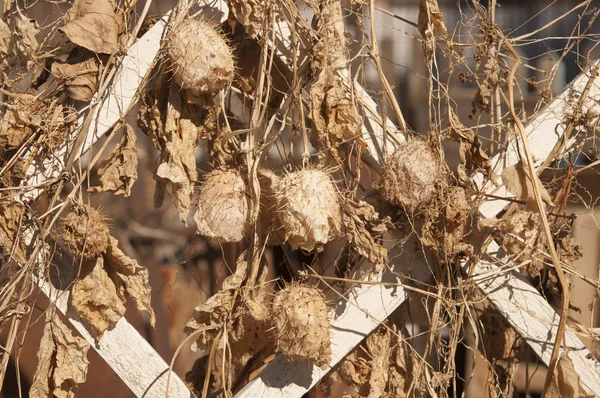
[{"xmin": 273, "ymin": 283, "xmax": 331, "ymax": 368}]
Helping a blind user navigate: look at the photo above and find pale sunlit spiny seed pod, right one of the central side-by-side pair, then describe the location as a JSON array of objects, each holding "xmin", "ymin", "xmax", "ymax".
[{"xmin": 276, "ymin": 169, "xmax": 341, "ymax": 251}]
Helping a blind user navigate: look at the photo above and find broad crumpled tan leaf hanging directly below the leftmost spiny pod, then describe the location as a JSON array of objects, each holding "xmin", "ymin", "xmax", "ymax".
[{"xmin": 71, "ymin": 256, "xmax": 125, "ymax": 339}]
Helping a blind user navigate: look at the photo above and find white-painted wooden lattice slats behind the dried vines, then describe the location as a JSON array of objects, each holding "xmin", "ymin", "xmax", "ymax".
[{"xmin": 14, "ymin": 0, "xmax": 600, "ymax": 397}]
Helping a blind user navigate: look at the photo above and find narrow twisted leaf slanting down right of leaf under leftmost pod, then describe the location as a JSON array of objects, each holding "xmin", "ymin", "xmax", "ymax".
[{"xmin": 106, "ymin": 236, "xmax": 156, "ymax": 326}]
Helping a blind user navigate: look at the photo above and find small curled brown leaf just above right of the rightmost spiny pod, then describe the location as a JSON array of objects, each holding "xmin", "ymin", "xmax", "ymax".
[{"xmin": 449, "ymin": 108, "xmax": 492, "ymax": 185}]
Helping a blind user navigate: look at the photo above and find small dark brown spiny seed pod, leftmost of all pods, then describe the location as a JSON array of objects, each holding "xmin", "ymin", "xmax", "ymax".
[{"xmin": 62, "ymin": 205, "xmax": 110, "ymax": 260}]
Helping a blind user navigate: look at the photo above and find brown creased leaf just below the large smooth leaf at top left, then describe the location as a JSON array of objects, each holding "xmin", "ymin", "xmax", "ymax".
[{"xmin": 52, "ymin": 54, "xmax": 100, "ymax": 102}]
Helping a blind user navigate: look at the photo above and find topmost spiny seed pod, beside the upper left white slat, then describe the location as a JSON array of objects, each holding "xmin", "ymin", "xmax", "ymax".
[{"xmin": 167, "ymin": 19, "xmax": 234, "ymax": 94}]
